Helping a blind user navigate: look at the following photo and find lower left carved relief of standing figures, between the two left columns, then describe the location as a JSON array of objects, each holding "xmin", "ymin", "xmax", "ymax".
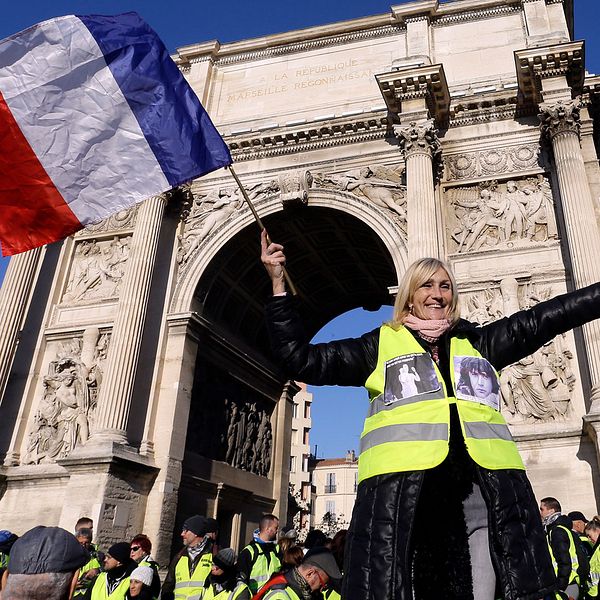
[{"xmin": 23, "ymin": 327, "xmax": 109, "ymax": 464}]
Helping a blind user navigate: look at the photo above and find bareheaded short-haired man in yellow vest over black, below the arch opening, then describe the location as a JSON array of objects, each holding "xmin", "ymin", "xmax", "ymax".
[{"xmin": 238, "ymin": 514, "xmax": 281, "ymax": 594}]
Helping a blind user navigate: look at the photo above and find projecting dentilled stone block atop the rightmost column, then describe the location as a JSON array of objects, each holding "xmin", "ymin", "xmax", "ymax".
[{"xmin": 515, "ymin": 41, "xmax": 585, "ymax": 104}]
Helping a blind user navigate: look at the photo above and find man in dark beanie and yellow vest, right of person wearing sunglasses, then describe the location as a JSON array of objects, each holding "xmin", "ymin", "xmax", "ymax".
[{"xmin": 160, "ymin": 515, "xmax": 213, "ymax": 600}]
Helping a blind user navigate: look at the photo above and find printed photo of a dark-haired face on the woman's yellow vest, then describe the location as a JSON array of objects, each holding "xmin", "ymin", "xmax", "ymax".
[{"xmin": 454, "ymin": 356, "xmax": 500, "ymax": 410}]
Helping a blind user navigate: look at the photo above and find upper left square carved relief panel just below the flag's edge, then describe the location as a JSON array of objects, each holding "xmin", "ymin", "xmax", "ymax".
[{"xmin": 61, "ymin": 236, "xmax": 131, "ymax": 304}]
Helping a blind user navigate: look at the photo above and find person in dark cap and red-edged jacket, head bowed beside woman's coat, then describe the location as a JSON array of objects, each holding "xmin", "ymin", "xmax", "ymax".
[{"xmin": 253, "ymin": 547, "xmax": 342, "ymax": 600}]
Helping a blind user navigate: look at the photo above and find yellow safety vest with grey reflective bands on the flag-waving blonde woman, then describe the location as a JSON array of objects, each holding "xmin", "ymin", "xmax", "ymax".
[{"xmin": 358, "ymin": 325, "xmax": 525, "ymax": 481}]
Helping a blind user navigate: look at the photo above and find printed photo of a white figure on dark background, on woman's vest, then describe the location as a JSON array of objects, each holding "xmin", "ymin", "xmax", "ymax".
[{"xmin": 384, "ymin": 353, "xmax": 441, "ymax": 404}]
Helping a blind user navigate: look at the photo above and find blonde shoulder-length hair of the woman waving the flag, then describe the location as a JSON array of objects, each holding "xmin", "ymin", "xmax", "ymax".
[{"xmin": 389, "ymin": 258, "xmax": 460, "ymax": 329}]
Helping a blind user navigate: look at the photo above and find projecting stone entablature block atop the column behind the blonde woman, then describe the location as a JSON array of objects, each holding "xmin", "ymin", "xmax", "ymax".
[{"xmin": 375, "ymin": 64, "xmax": 450, "ymax": 127}]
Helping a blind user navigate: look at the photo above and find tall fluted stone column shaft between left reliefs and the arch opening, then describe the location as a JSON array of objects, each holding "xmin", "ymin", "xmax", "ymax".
[{"xmin": 89, "ymin": 194, "xmax": 167, "ymax": 445}]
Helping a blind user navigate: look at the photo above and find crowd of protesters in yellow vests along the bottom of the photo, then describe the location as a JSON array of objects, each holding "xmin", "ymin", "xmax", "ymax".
[{"xmin": 0, "ymin": 497, "xmax": 600, "ymax": 600}]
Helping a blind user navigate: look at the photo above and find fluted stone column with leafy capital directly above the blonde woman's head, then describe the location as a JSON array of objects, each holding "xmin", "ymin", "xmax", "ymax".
[{"xmin": 394, "ymin": 120, "xmax": 442, "ymax": 263}]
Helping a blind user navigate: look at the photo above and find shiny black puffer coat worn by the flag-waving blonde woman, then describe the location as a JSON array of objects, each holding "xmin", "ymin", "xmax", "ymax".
[{"xmin": 267, "ymin": 284, "xmax": 600, "ymax": 600}]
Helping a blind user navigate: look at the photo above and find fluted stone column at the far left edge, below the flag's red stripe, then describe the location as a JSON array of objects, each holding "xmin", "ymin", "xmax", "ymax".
[{"xmin": 0, "ymin": 247, "xmax": 42, "ymax": 402}]
